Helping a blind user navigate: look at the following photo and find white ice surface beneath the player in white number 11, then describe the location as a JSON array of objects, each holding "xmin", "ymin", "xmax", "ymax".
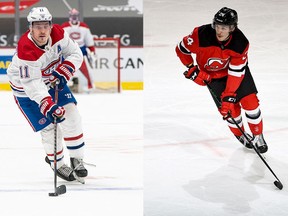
[{"xmin": 0, "ymin": 91, "xmax": 143, "ymax": 216}]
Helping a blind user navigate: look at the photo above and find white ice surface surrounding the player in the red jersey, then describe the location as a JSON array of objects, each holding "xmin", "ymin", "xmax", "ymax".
[{"xmin": 144, "ymin": 0, "xmax": 288, "ymax": 216}]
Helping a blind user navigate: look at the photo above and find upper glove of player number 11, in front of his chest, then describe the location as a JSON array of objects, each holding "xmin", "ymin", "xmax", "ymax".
[{"xmin": 49, "ymin": 64, "xmax": 74, "ymax": 90}]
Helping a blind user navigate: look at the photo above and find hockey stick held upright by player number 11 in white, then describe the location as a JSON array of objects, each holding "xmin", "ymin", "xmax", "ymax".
[{"xmin": 49, "ymin": 82, "xmax": 66, "ymax": 196}]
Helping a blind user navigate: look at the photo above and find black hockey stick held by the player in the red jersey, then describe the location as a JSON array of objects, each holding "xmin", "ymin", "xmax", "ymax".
[{"xmin": 204, "ymin": 81, "xmax": 283, "ymax": 190}]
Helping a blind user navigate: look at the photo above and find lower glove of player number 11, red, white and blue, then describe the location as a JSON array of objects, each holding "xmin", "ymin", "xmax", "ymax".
[{"xmin": 39, "ymin": 96, "xmax": 65, "ymax": 123}]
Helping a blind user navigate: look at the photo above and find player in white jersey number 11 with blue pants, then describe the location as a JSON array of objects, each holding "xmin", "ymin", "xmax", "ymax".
[{"xmin": 7, "ymin": 7, "xmax": 88, "ymax": 181}]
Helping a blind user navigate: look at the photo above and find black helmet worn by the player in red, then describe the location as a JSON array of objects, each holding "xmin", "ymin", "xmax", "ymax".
[{"xmin": 212, "ymin": 7, "xmax": 238, "ymax": 27}]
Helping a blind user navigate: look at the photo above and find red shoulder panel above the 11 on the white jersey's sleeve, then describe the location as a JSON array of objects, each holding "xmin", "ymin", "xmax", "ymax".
[{"xmin": 17, "ymin": 31, "xmax": 44, "ymax": 61}]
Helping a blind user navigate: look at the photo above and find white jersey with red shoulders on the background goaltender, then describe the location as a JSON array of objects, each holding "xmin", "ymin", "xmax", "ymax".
[{"xmin": 62, "ymin": 22, "xmax": 94, "ymax": 47}]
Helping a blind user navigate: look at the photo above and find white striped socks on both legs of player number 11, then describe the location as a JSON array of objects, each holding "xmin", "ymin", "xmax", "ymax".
[{"xmin": 41, "ymin": 103, "xmax": 85, "ymax": 168}]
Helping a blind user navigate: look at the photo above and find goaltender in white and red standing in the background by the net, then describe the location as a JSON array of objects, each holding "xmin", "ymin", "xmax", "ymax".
[{"xmin": 62, "ymin": 9, "xmax": 95, "ymax": 91}]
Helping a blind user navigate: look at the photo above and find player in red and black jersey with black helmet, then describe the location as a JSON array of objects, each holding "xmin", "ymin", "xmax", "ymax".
[{"xmin": 176, "ymin": 7, "xmax": 268, "ymax": 153}]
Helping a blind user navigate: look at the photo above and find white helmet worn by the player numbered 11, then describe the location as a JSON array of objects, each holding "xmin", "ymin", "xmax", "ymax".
[{"xmin": 27, "ymin": 7, "xmax": 52, "ymax": 24}]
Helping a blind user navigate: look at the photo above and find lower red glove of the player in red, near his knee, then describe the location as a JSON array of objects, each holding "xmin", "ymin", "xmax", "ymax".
[{"xmin": 219, "ymin": 92, "xmax": 237, "ymax": 120}]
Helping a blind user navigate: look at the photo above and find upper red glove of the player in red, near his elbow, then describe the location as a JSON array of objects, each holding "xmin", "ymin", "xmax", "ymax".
[{"xmin": 184, "ymin": 64, "xmax": 211, "ymax": 86}]
